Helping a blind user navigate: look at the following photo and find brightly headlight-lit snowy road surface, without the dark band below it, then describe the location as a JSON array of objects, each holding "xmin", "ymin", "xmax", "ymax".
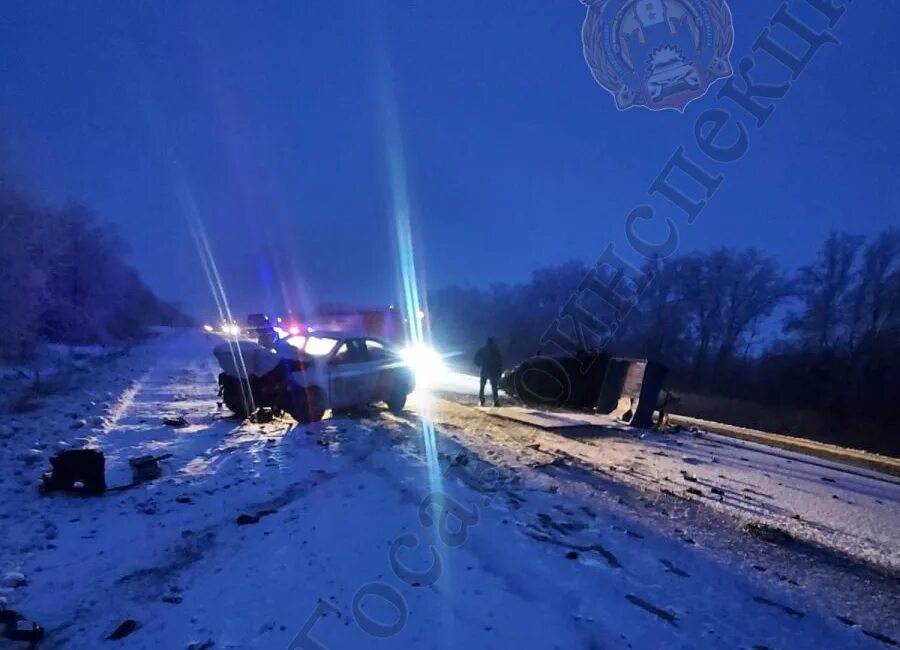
[{"xmin": 428, "ymin": 388, "xmax": 900, "ymax": 574}]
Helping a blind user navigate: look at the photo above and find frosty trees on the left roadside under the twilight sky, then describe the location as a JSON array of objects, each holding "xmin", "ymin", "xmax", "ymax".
[{"xmin": 0, "ymin": 173, "xmax": 185, "ymax": 361}]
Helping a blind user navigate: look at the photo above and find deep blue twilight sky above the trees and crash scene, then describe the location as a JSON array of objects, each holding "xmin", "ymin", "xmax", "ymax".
[{"xmin": 0, "ymin": 0, "xmax": 900, "ymax": 315}]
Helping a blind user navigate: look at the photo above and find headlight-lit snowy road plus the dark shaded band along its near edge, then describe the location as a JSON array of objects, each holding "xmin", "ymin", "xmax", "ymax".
[{"xmin": 426, "ymin": 394, "xmax": 900, "ymax": 624}]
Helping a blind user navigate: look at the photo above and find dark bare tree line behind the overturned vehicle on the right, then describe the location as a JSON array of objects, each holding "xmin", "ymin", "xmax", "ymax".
[{"xmin": 429, "ymin": 229, "xmax": 900, "ymax": 448}]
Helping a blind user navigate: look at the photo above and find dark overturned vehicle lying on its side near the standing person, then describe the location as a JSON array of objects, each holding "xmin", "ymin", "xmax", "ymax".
[{"xmin": 500, "ymin": 351, "xmax": 666, "ymax": 427}]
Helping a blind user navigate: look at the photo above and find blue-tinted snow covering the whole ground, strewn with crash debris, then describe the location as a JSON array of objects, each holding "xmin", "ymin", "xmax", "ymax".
[{"xmin": 0, "ymin": 334, "xmax": 900, "ymax": 650}]
